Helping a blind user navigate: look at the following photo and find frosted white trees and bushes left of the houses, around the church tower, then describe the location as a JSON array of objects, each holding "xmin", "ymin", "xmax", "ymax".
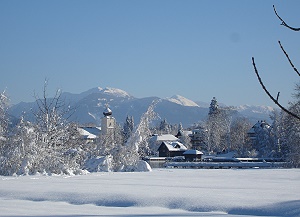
[{"xmin": 0, "ymin": 82, "xmax": 154, "ymax": 175}]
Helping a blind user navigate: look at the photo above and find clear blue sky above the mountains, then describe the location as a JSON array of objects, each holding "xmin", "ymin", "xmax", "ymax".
[{"xmin": 0, "ymin": 0, "xmax": 300, "ymax": 106}]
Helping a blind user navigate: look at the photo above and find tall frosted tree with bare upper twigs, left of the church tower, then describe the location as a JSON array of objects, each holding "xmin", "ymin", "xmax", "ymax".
[{"xmin": 28, "ymin": 81, "xmax": 80, "ymax": 173}]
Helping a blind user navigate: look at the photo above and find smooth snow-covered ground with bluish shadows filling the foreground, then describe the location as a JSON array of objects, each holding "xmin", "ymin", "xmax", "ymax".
[{"xmin": 0, "ymin": 169, "xmax": 300, "ymax": 217}]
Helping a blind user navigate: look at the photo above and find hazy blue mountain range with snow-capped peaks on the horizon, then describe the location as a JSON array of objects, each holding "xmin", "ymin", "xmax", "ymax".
[{"xmin": 9, "ymin": 87, "xmax": 274, "ymax": 127}]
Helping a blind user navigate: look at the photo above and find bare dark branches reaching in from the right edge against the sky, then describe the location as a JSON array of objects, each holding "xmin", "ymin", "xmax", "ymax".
[{"xmin": 252, "ymin": 5, "xmax": 300, "ymax": 120}]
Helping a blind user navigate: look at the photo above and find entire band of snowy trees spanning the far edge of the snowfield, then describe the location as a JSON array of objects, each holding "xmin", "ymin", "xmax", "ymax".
[{"xmin": 0, "ymin": 84, "xmax": 300, "ymax": 175}]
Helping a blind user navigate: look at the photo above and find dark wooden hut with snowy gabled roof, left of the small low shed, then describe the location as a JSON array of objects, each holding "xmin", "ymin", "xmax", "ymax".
[{"xmin": 158, "ymin": 141, "xmax": 187, "ymax": 157}]
